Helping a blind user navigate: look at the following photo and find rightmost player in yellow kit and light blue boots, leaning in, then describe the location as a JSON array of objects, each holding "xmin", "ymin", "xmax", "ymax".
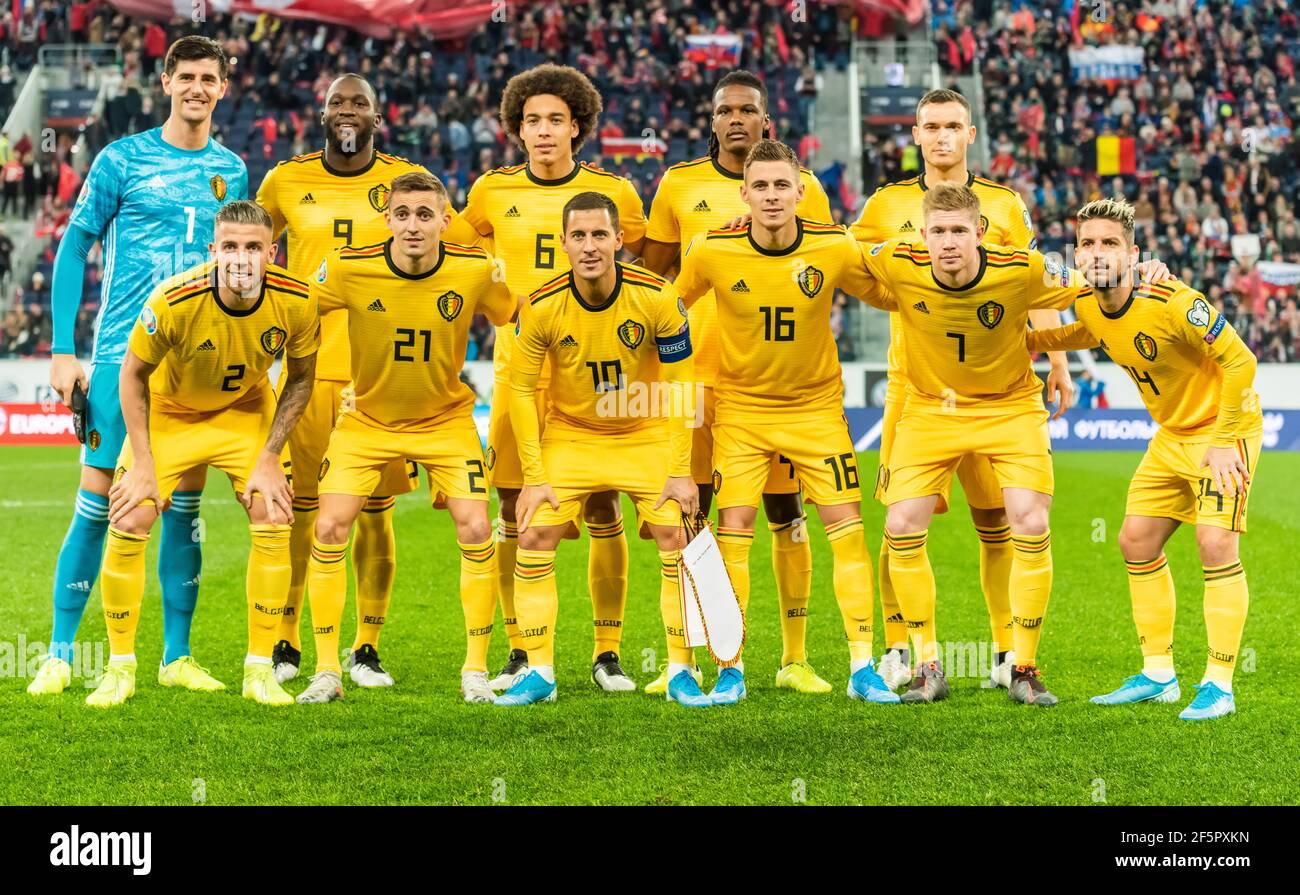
[{"xmin": 1030, "ymin": 199, "xmax": 1262, "ymax": 721}]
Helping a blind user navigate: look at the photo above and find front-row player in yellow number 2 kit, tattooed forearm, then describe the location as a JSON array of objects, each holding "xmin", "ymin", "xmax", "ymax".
[{"xmin": 86, "ymin": 200, "xmax": 320, "ymax": 708}]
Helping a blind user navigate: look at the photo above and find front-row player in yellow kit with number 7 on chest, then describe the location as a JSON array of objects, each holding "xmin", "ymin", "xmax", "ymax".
[{"xmin": 863, "ymin": 183, "xmax": 1107, "ymax": 705}]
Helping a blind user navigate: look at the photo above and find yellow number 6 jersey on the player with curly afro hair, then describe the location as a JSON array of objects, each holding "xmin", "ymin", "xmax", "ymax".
[{"xmin": 446, "ymin": 161, "xmax": 646, "ymax": 381}]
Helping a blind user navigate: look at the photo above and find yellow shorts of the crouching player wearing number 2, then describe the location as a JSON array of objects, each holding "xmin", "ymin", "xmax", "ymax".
[{"xmin": 113, "ymin": 390, "xmax": 287, "ymax": 503}]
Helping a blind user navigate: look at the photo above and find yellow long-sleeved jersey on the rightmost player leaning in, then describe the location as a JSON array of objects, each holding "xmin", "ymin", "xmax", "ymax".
[{"xmin": 1031, "ymin": 280, "xmax": 1264, "ymax": 448}]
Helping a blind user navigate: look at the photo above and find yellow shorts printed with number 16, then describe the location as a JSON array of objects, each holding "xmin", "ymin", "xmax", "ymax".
[{"xmin": 714, "ymin": 412, "xmax": 862, "ymax": 509}]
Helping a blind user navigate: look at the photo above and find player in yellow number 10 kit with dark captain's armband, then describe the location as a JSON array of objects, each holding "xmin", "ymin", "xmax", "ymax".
[{"xmin": 497, "ymin": 193, "xmax": 710, "ymax": 706}]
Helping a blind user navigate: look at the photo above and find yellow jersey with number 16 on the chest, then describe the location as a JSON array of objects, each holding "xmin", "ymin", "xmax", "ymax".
[{"xmin": 677, "ymin": 219, "xmax": 878, "ymax": 414}]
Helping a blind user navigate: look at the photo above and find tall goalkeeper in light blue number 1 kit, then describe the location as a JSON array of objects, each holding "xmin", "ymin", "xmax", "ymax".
[{"xmin": 27, "ymin": 35, "xmax": 248, "ymax": 695}]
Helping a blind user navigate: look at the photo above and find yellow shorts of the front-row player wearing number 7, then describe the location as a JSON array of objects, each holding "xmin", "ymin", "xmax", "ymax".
[{"xmin": 876, "ymin": 405, "xmax": 1054, "ymax": 506}]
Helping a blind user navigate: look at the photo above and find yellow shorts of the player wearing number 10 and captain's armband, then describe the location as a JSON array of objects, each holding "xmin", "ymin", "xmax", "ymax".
[{"xmin": 530, "ymin": 427, "xmax": 681, "ymax": 528}]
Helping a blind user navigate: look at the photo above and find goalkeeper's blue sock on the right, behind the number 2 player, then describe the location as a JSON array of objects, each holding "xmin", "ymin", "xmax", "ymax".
[{"xmin": 159, "ymin": 490, "xmax": 203, "ymax": 665}]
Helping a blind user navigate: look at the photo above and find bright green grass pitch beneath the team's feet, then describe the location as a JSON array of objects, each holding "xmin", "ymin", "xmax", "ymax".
[{"xmin": 0, "ymin": 448, "xmax": 1300, "ymax": 805}]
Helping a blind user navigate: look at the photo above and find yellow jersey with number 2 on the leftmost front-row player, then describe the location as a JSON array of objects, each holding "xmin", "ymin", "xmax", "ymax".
[{"xmin": 130, "ymin": 261, "xmax": 320, "ymax": 412}]
